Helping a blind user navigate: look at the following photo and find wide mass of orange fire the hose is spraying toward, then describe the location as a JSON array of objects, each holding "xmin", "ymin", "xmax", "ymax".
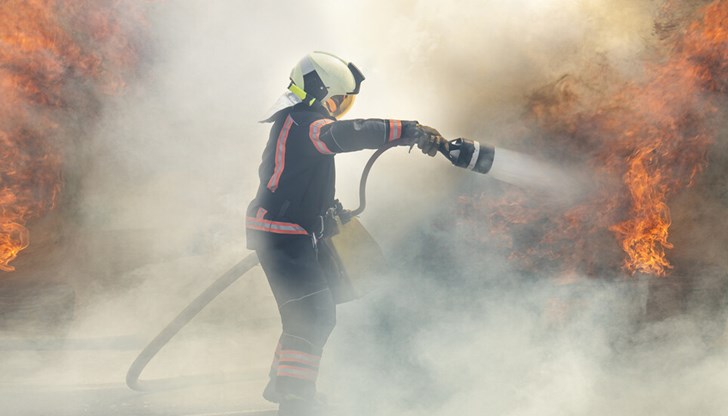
[{"xmin": 478, "ymin": 1, "xmax": 728, "ymax": 276}]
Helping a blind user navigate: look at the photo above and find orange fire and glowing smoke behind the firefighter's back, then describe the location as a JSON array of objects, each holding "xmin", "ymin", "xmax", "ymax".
[{"xmin": 0, "ymin": 0, "xmax": 143, "ymax": 272}]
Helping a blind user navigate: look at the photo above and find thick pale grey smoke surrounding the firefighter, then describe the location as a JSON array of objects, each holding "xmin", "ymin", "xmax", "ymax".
[{"xmin": 2, "ymin": 0, "xmax": 728, "ymax": 415}]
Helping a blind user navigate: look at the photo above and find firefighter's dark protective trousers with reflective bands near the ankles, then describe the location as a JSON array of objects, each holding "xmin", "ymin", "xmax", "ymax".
[{"xmin": 256, "ymin": 235, "xmax": 336, "ymax": 400}]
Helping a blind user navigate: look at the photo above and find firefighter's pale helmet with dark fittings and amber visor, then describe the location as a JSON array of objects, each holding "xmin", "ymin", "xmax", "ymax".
[{"xmin": 288, "ymin": 51, "xmax": 364, "ymax": 118}]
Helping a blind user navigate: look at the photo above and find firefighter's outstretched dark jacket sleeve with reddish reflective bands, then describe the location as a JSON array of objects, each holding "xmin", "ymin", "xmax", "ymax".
[{"xmin": 309, "ymin": 119, "xmax": 418, "ymax": 154}]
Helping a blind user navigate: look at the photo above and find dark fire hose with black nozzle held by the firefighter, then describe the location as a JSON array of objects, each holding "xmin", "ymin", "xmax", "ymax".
[{"xmin": 126, "ymin": 139, "xmax": 494, "ymax": 391}]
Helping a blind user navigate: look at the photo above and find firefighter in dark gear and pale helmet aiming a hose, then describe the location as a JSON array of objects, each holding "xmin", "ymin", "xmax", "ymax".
[{"xmin": 246, "ymin": 52, "xmax": 444, "ymax": 416}]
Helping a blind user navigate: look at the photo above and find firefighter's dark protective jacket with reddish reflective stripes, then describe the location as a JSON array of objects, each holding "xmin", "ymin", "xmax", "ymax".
[{"xmin": 246, "ymin": 104, "xmax": 416, "ymax": 249}]
